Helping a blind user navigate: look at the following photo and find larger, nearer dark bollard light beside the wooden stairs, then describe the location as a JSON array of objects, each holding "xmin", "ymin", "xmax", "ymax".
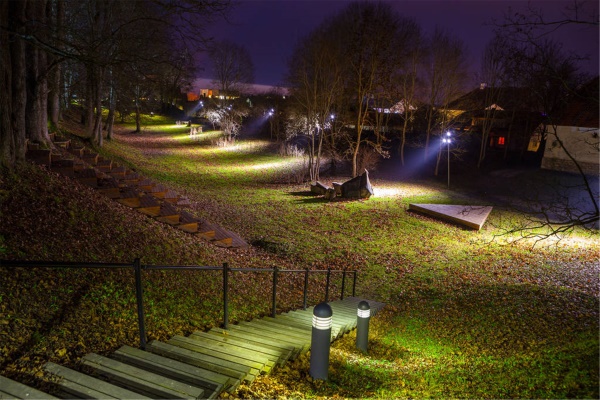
[{"xmin": 310, "ymin": 303, "xmax": 333, "ymax": 380}]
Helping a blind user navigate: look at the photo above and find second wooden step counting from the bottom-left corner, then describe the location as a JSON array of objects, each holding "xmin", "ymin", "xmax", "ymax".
[{"xmin": 44, "ymin": 362, "xmax": 149, "ymax": 399}]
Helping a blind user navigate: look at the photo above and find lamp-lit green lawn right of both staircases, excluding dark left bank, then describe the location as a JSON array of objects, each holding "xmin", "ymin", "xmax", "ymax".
[{"xmin": 96, "ymin": 119, "xmax": 599, "ymax": 398}]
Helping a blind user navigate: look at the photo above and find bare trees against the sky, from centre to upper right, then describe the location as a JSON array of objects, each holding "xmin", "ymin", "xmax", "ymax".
[{"xmin": 272, "ymin": 2, "xmax": 598, "ymax": 180}]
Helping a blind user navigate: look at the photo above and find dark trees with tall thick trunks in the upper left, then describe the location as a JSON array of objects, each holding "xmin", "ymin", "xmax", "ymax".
[{"xmin": 0, "ymin": 0, "xmax": 230, "ymax": 168}]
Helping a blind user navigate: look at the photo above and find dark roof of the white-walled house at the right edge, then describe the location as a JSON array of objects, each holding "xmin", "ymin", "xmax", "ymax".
[{"xmin": 558, "ymin": 77, "xmax": 599, "ymax": 128}]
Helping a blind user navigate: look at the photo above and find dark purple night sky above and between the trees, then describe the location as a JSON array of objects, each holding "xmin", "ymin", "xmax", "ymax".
[{"xmin": 200, "ymin": 0, "xmax": 598, "ymax": 85}]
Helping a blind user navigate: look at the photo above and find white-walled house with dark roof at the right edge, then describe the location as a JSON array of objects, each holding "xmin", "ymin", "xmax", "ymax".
[{"xmin": 542, "ymin": 77, "xmax": 600, "ymax": 175}]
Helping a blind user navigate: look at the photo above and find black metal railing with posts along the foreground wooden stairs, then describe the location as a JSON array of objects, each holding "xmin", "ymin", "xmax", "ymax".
[{"xmin": 0, "ymin": 258, "xmax": 357, "ymax": 349}]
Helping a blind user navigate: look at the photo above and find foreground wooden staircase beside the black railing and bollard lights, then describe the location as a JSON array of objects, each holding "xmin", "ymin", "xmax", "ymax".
[{"xmin": 0, "ymin": 297, "xmax": 384, "ymax": 399}]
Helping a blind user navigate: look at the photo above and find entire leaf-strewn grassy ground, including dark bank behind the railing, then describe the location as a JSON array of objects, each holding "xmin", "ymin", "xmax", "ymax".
[{"xmin": 0, "ymin": 115, "xmax": 598, "ymax": 398}]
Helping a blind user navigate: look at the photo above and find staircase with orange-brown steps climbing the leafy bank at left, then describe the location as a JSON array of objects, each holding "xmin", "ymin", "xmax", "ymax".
[{"xmin": 26, "ymin": 135, "xmax": 248, "ymax": 248}]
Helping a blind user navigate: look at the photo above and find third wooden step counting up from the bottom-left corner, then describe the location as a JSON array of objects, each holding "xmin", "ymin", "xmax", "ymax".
[{"xmin": 81, "ymin": 353, "xmax": 204, "ymax": 399}]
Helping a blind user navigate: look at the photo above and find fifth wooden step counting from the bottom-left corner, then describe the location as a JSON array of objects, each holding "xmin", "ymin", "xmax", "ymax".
[{"xmin": 146, "ymin": 340, "xmax": 250, "ymax": 387}]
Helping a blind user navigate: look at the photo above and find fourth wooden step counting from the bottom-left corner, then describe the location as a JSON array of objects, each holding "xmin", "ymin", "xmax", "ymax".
[{"xmin": 113, "ymin": 346, "xmax": 229, "ymax": 399}]
